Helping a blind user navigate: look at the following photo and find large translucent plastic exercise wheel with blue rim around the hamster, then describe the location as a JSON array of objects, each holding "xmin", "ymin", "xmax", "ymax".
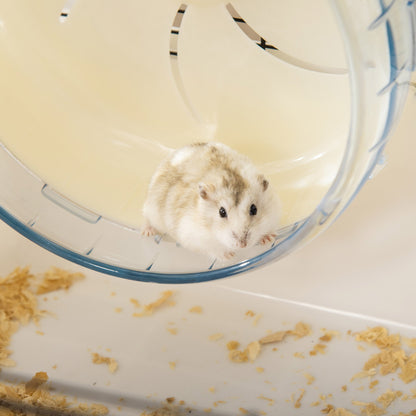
[{"xmin": 0, "ymin": 0, "xmax": 414, "ymax": 283}]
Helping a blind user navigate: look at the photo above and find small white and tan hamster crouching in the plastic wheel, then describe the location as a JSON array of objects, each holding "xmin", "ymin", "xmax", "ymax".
[{"xmin": 142, "ymin": 142, "xmax": 279, "ymax": 260}]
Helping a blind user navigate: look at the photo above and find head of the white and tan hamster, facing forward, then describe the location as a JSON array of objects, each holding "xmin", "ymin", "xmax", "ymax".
[{"xmin": 199, "ymin": 174, "xmax": 279, "ymax": 251}]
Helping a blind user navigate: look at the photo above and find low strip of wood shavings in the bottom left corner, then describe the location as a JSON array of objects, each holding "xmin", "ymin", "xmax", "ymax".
[{"xmin": 0, "ymin": 371, "xmax": 108, "ymax": 416}]
